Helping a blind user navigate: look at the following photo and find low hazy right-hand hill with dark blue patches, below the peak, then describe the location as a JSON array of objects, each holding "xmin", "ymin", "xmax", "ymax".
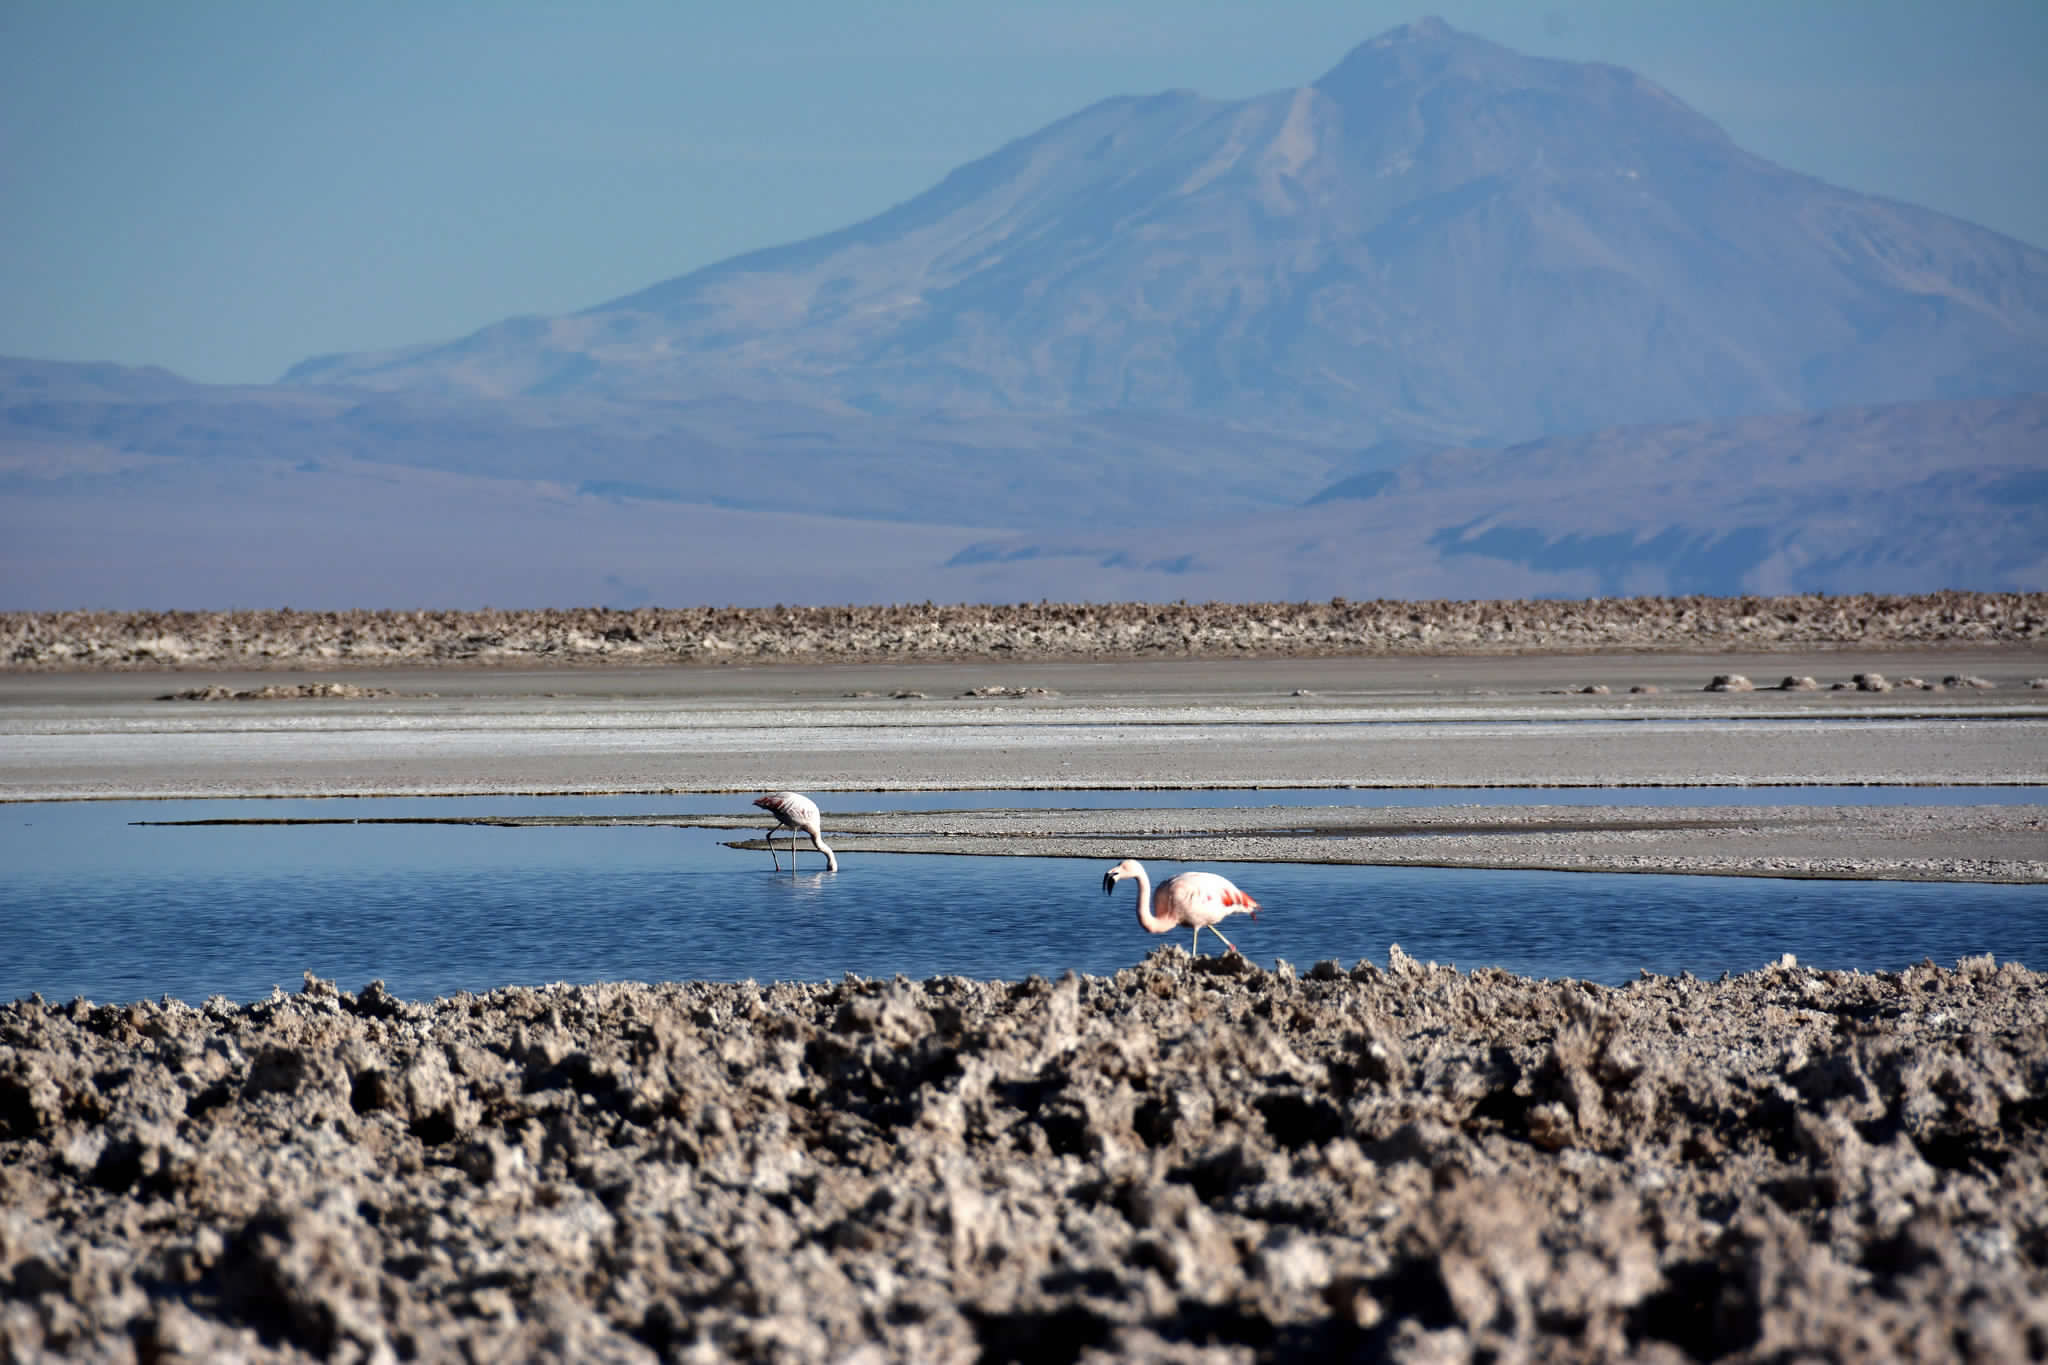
[{"xmin": 950, "ymin": 395, "xmax": 2048, "ymax": 602}]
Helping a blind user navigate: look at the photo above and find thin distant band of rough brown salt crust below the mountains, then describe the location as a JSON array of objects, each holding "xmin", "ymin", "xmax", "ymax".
[{"xmin": 0, "ymin": 591, "xmax": 2048, "ymax": 671}]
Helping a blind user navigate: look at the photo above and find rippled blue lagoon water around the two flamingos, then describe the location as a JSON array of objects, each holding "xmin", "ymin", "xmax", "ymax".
[{"xmin": 0, "ymin": 788, "xmax": 2048, "ymax": 1003}]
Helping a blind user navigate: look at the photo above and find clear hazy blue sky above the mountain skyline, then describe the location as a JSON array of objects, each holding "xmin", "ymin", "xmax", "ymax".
[{"xmin": 12, "ymin": 0, "xmax": 2048, "ymax": 381}]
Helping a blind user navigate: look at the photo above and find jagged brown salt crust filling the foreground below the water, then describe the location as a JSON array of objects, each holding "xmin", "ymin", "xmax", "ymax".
[{"xmin": 0, "ymin": 948, "xmax": 2048, "ymax": 1363}]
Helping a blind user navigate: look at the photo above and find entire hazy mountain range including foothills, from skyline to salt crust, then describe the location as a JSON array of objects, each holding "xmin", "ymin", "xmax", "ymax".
[{"xmin": 0, "ymin": 20, "xmax": 2048, "ymax": 610}]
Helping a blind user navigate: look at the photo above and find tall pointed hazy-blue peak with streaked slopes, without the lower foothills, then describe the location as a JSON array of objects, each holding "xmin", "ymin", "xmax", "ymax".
[{"xmin": 287, "ymin": 20, "xmax": 2048, "ymax": 448}]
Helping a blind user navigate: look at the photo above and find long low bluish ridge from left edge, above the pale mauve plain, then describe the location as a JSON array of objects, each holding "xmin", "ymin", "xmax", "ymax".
[{"xmin": 0, "ymin": 358, "xmax": 1376, "ymax": 528}]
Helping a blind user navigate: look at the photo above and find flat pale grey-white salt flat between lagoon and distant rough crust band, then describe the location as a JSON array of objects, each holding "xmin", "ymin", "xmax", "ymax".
[{"xmin": 0, "ymin": 649, "xmax": 2048, "ymax": 800}]
